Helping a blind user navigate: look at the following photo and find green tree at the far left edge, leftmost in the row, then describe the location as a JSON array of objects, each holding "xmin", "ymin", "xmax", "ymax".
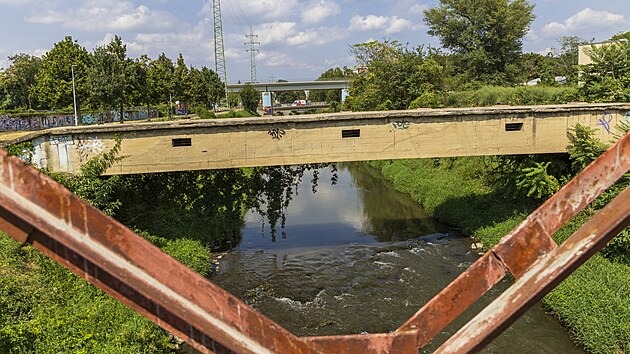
[{"xmin": 0, "ymin": 53, "xmax": 42, "ymax": 109}]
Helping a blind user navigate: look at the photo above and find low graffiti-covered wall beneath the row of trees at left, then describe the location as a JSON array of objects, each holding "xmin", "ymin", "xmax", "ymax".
[{"xmin": 0, "ymin": 108, "xmax": 158, "ymax": 131}]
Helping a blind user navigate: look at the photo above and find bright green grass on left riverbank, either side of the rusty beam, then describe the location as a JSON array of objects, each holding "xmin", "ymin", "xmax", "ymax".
[{"xmin": 0, "ymin": 227, "xmax": 211, "ymax": 354}]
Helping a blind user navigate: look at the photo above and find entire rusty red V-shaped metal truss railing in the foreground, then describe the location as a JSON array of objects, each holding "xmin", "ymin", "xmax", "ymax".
[{"xmin": 0, "ymin": 131, "xmax": 630, "ymax": 353}]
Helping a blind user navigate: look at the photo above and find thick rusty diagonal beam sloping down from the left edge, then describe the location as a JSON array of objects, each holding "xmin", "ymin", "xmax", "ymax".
[{"xmin": 0, "ymin": 150, "xmax": 314, "ymax": 353}]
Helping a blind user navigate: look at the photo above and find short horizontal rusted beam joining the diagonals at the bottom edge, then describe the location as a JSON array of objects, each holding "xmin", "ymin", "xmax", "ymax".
[{"xmin": 302, "ymin": 332, "xmax": 418, "ymax": 354}]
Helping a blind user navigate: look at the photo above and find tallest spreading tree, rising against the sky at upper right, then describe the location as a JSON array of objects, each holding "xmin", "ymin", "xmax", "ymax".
[{"xmin": 424, "ymin": 0, "xmax": 534, "ymax": 84}]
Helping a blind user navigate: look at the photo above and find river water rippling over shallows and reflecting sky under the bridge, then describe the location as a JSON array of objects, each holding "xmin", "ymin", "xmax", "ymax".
[{"xmin": 212, "ymin": 164, "xmax": 581, "ymax": 353}]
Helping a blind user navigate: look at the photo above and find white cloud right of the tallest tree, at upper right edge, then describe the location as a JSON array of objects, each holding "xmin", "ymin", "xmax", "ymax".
[{"xmin": 542, "ymin": 7, "xmax": 629, "ymax": 37}]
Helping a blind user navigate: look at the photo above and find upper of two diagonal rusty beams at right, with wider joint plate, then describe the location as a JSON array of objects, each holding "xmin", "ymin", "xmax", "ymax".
[{"xmin": 397, "ymin": 134, "xmax": 630, "ymax": 347}]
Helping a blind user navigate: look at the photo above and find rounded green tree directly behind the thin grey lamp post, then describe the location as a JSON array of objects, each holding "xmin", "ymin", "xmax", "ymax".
[{"xmin": 35, "ymin": 36, "xmax": 91, "ymax": 111}]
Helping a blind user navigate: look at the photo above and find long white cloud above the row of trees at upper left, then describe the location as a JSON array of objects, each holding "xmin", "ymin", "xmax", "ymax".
[{"xmin": 25, "ymin": 0, "xmax": 175, "ymax": 32}]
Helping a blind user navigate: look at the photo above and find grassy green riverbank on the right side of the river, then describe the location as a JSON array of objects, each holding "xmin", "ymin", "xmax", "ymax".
[{"xmin": 371, "ymin": 157, "xmax": 630, "ymax": 353}]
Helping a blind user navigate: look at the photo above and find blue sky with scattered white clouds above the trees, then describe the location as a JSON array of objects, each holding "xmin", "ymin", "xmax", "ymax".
[{"xmin": 0, "ymin": 0, "xmax": 630, "ymax": 83}]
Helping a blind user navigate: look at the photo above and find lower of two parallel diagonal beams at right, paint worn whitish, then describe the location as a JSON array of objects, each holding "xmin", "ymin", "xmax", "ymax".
[{"xmin": 436, "ymin": 187, "xmax": 630, "ymax": 353}]
